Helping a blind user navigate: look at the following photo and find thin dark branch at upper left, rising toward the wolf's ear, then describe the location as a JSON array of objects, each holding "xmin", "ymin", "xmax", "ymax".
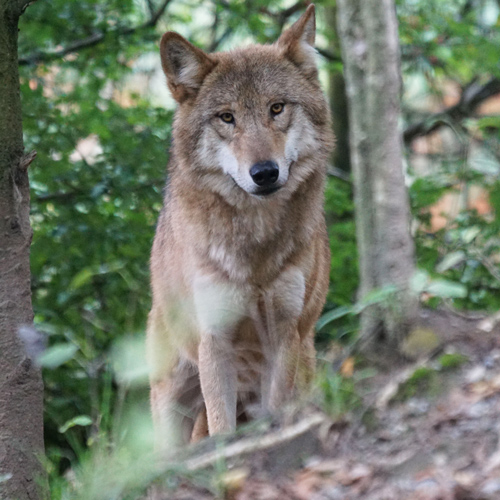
[{"xmin": 19, "ymin": 0, "xmax": 172, "ymax": 66}]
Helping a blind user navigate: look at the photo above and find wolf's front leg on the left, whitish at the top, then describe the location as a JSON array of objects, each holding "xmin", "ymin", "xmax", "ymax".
[{"xmin": 194, "ymin": 276, "xmax": 246, "ymax": 435}]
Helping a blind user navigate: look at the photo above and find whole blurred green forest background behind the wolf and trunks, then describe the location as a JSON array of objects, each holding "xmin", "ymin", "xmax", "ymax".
[{"xmin": 9, "ymin": 0, "xmax": 500, "ymax": 498}]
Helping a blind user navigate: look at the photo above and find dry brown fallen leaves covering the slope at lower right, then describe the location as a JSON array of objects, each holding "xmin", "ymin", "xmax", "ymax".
[{"xmin": 157, "ymin": 312, "xmax": 500, "ymax": 500}]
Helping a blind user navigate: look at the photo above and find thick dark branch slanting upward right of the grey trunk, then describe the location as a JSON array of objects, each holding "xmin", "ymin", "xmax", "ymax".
[{"xmin": 403, "ymin": 78, "xmax": 500, "ymax": 144}]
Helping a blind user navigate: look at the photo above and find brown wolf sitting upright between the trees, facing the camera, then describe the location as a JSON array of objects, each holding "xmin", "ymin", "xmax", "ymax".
[{"xmin": 147, "ymin": 5, "xmax": 333, "ymax": 447}]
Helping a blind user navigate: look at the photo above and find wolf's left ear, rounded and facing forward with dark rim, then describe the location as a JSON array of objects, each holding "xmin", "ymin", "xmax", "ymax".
[{"xmin": 160, "ymin": 31, "xmax": 216, "ymax": 103}]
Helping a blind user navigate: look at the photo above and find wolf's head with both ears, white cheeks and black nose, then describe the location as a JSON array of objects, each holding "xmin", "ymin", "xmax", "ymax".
[{"xmin": 160, "ymin": 5, "xmax": 332, "ymax": 202}]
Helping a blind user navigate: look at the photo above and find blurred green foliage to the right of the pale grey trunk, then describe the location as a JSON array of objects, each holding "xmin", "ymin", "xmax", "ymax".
[{"xmin": 398, "ymin": 0, "xmax": 500, "ymax": 311}]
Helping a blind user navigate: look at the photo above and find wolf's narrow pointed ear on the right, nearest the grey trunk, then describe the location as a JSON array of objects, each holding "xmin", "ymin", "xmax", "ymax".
[{"xmin": 276, "ymin": 4, "xmax": 318, "ymax": 77}]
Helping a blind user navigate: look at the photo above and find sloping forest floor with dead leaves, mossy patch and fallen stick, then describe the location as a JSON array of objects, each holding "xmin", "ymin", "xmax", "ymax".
[{"xmin": 151, "ymin": 311, "xmax": 500, "ymax": 500}]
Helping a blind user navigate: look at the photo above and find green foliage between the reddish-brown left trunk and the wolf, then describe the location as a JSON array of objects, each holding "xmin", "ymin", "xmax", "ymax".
[{"xmin": 20, "ymin": 1, "xmax": 172, "ymax": 474}]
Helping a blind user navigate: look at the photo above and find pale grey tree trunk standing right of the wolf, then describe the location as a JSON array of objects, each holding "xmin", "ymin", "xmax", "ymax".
[{"xmin": 338, "ymin": 0, "xmax": 418, "ymax": 348}]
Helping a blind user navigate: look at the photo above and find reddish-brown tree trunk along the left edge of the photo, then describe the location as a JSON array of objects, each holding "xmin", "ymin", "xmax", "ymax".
[{"xmin": 0, "ymin": 0, "xmax": 43, "ymax": 500}]
